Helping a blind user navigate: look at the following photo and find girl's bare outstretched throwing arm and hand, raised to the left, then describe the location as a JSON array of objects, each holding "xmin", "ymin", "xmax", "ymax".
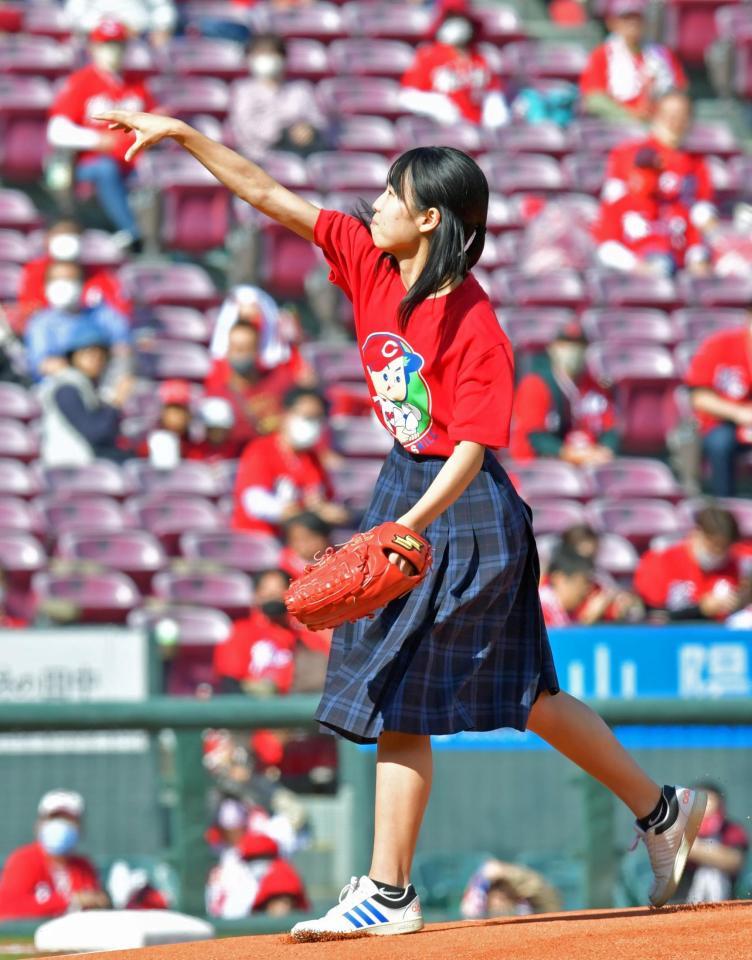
[{"xmin": 95, "ymin": 110, "xmax": 319, "ymax": 240}]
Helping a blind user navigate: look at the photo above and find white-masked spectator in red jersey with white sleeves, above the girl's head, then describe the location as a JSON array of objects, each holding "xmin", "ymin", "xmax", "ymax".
[{"xmin": 402, "ymin": 0, "xmax": 509, "ymax": 129}]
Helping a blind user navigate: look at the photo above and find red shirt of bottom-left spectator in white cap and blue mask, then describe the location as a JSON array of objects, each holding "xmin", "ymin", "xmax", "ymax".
[{"xmin": 0, "ymin": 842, "xmax": 102, "ymax": 920}]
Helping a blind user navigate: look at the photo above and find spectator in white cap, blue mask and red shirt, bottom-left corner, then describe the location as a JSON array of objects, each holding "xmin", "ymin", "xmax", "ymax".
[{"xmin": 0, "ymin": 790, "xmax": 110, "ymax": 920}]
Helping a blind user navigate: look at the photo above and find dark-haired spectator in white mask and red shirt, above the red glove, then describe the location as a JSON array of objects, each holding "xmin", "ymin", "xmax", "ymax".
[{"xmin": 232, "ymin": 387, "xmax": 348, "ymax": 534}]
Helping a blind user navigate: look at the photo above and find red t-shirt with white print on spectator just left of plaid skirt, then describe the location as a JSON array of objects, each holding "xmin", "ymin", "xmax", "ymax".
[{"xmin": 214, "ymin": 610, "xmax": 297, "ymax": 693}]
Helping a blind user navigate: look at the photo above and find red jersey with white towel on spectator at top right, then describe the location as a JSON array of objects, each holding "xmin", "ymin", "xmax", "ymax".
[{"xmin": 580, "ymin": 36, "xmax": 687, "ymax": 114}]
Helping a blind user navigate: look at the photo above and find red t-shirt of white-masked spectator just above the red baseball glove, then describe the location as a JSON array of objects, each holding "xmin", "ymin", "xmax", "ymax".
[{"xmin": 232, "ymin": 433, "xmax": 334, "ymax": 534}]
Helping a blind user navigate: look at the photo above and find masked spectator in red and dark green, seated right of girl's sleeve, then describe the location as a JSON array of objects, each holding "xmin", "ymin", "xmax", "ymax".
[{"xmin": 510, "ymin": 322, "xmax": 619, "ymax": 465}]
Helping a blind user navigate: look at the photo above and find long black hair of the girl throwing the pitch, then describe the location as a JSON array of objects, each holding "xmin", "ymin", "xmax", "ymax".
[{"xmin": 360, "ymin": 147, "xmax": 488, "ymax": 330}]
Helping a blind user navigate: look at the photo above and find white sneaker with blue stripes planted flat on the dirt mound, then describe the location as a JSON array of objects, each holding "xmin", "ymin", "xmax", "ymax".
[{"xmin": 290, "ymin": 876, "xmax": 423, "ymax": 940}]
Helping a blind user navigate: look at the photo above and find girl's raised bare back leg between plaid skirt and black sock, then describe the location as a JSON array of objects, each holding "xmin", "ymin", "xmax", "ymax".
[{"xmin": 528, "ymin": 692, "xmax": 661, "ymax": 817}]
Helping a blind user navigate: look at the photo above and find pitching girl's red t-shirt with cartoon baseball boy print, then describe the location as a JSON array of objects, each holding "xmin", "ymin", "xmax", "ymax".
[{"xmin": 314, "ymin": 210, "xmax": 514, "ymax": 457}]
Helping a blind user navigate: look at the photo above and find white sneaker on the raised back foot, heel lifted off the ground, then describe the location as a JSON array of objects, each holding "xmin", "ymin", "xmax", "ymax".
[{"xmin": 633, "ymin": 787, "xmax": 708, "ymax": 907}]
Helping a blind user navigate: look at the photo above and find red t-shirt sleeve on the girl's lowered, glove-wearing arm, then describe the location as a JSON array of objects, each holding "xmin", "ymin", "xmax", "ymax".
[{"xmin": 447, "ymin": 344, "xmax": 514, "ymax": 447}]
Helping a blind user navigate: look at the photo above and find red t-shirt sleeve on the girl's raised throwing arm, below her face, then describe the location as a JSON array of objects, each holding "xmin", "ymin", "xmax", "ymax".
[{"xmin": 313, "ymin": 210, "xmax": 381, "ymax": 300}]
